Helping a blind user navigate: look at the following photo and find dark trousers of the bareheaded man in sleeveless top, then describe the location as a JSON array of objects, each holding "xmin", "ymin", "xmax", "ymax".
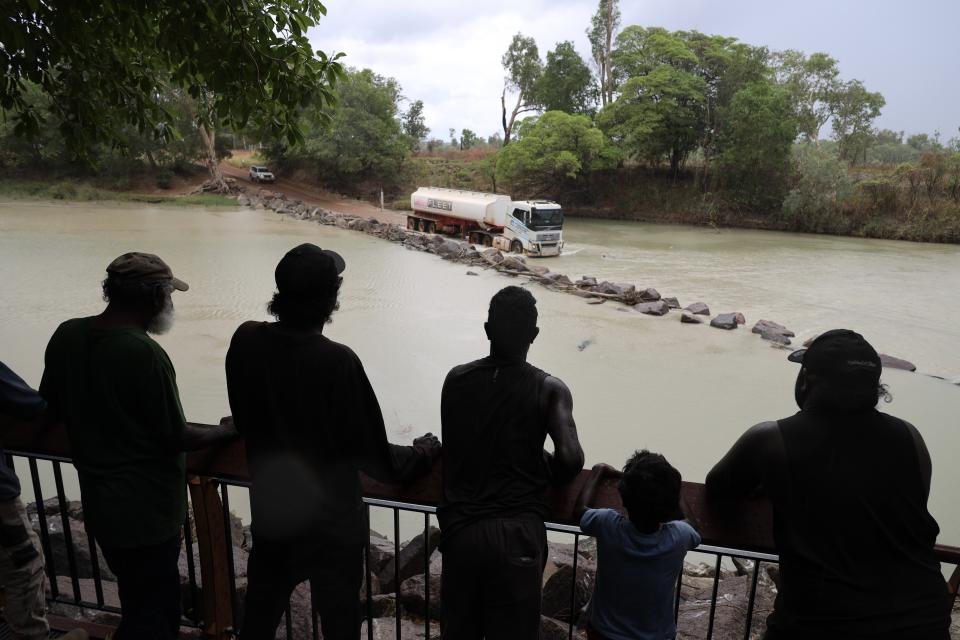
[{"xmin": 440, "ymin": 515, "xmax": 547, "ymax": 640}]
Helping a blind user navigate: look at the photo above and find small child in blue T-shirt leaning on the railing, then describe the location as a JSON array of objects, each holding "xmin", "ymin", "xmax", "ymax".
[{"xmin": 574, "ymin": 450, "xmax": 700, "ymax": 640}]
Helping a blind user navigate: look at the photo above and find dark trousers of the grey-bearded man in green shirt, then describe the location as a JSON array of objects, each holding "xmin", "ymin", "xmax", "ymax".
[{"xmin": 102, "ymin": 535, "xmax": 180, "ymax": 640}]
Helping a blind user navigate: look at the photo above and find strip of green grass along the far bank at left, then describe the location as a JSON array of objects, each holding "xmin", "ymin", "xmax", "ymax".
[{"xmin": 0, "ymin": 179, "xmax": 237, "ymax": 207}]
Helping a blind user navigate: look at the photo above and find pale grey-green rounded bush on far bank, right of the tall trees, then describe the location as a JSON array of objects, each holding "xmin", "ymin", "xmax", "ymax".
[{"xmin": 783, "ymin": 146, "xmax": 853, "ymax": 231}]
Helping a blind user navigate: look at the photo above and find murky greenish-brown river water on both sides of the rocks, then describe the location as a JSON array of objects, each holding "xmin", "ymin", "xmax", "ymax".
[{"xmin": 0, "ymin": 202, "xmax": 960, "ymax": 545}]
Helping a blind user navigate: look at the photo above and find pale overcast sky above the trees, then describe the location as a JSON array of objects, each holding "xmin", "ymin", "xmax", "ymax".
[{"xmin": 311, "ymin": 0, "xmax": 960, "ymax": 140}]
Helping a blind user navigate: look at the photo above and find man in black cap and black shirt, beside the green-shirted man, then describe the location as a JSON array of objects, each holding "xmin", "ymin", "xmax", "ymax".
[{"xmin": 226, "ymin": 244, "xmax": 440, "ymax": 640}]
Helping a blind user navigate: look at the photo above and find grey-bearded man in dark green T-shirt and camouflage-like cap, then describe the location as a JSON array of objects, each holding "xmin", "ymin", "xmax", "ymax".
[{"xmin": 40, "ymin": 252, "xmax": 235, "ymax": 640}]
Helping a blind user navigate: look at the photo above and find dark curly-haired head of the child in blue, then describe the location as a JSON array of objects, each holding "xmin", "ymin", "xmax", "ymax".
[{"xmin": 619, "ymin": 449, "xmax": 683, "ymax": 533}]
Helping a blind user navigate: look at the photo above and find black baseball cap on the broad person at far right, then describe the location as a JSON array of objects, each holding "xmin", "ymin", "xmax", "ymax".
[{"xmin": 787, "ymin": 329, "xmax": 883, "ymax": 380}]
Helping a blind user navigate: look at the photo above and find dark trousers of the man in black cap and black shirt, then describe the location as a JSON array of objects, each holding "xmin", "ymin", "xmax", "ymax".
[{"xmin": 240, "ymin": 534, "xmax": 363, "ymax": 640}]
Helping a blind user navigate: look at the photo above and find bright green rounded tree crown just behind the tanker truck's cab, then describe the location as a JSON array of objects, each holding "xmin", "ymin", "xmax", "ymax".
[{"xmin": 496, "ymin": 111, "xmax": 619, "ymax": 196}]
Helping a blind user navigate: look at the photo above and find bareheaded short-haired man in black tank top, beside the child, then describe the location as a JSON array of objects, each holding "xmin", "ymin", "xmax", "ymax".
[{"xmin": 437, "ymin": 287, "xmax": 583, "ymax": 640}]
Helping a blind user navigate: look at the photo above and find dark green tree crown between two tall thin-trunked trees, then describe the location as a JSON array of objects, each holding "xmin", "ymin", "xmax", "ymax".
[{"xmin": 534, "ymin": 40, "xmax": 597, "ymax": 114}]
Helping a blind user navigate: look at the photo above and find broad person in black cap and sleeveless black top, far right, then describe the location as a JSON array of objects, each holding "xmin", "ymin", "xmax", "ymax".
[{"xmin": 707, "ymin": 329, "xmax": 950, "ymax": 640}]
